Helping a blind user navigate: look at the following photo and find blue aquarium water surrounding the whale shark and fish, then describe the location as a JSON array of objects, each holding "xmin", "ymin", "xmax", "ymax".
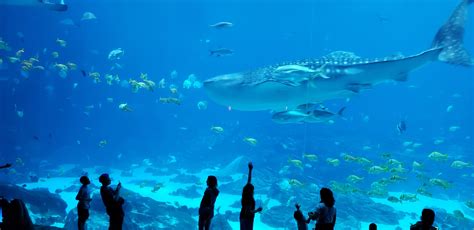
[{"xmin": 0, "ymin": 0, "xmax": 474, "ymax": 229}]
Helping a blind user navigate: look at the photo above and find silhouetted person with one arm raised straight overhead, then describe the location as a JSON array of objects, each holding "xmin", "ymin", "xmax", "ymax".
[{"xmin": 240, "ymin": 162, "xmax": 263, "ymax": 230}]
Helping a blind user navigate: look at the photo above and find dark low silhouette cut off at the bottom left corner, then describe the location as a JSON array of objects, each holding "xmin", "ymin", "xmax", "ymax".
[{"xmin": 0, "ymin": 197, "xmax": 34, "ymax": 230}]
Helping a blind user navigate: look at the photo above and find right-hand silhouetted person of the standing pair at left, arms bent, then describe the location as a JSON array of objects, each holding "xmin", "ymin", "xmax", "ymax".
[{"xmin": 99, "ymin": 173, "xmax": 125, "ymax": 230}]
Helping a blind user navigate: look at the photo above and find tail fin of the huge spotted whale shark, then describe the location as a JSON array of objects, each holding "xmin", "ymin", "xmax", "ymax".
[{"xmin": 433, "ymin": 0, "xmax": 474, "ymax": 66}]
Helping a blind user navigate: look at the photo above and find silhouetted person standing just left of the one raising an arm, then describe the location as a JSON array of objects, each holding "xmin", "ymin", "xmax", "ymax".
[{"xmin": 198, "ymin": 176, "xmax": 219, "ymax": 230}]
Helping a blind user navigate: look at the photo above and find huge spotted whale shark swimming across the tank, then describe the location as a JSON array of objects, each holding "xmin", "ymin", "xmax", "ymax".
[{"xmin": 204, "ymin": 0, "xmax": 474, "ymax": 111}]
